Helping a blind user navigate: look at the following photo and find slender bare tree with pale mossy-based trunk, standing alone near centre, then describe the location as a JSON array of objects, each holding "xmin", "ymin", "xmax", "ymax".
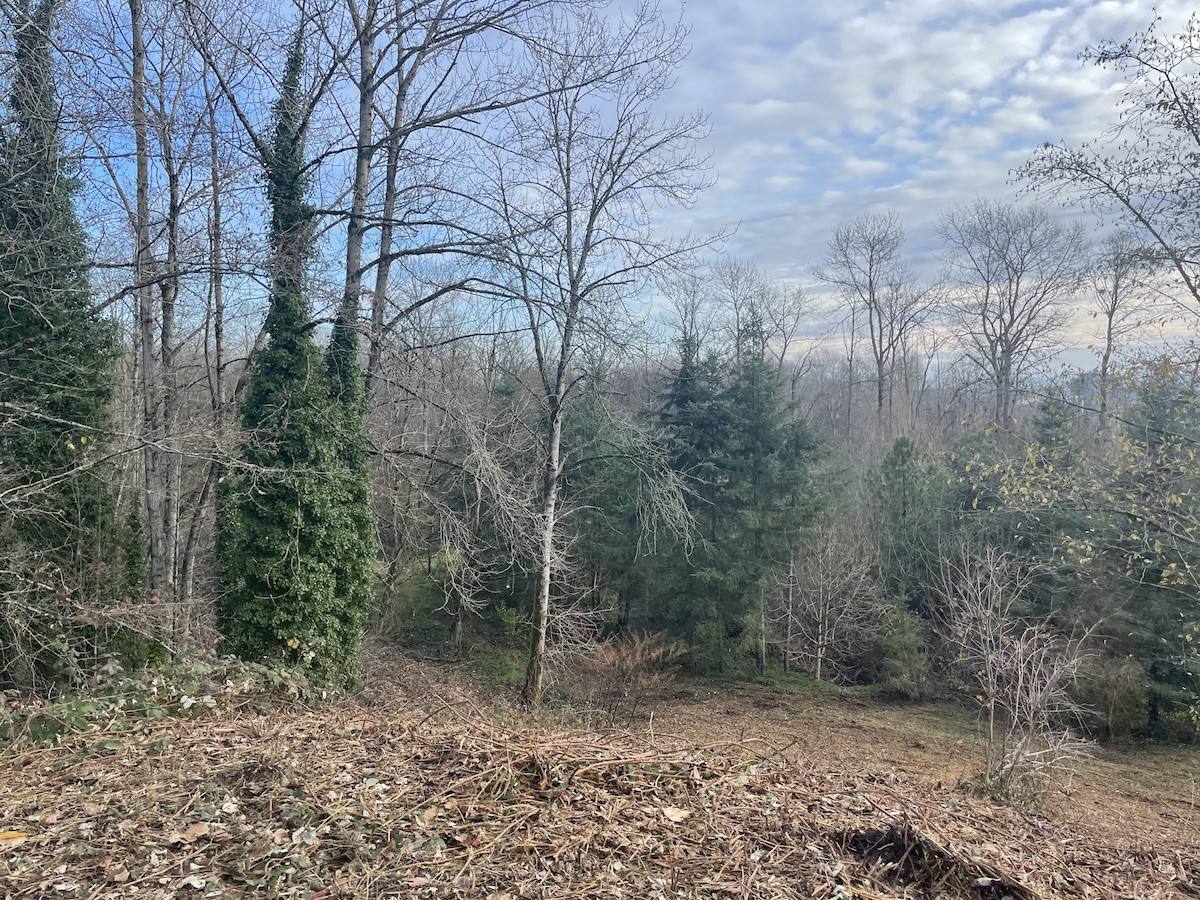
[{"xmin": 484, "ymin": 5, "xmax": 704, "ymax": 704}]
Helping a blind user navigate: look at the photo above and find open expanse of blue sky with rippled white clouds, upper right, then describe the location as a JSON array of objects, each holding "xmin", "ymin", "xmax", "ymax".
[{"xmin": 672, "ymin": 0, "xmax": 1190, "ymax": 281}]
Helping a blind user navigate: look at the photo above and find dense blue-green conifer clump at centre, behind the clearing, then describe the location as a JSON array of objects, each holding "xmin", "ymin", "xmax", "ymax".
[{"xmin": 650, "ymin": 317, "xmax": 817, "ymax": 672}]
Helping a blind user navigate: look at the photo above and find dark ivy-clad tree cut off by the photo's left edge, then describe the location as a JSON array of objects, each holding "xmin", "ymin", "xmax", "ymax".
[{"xmin": 0, "ymin": 0, "xmax": 115, "ymax": 688}]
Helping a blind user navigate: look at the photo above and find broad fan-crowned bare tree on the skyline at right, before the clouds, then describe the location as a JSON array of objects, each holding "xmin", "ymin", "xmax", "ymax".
[{"xmin": 938, "ymin": 199, "xmax": 1086, "ymax": 426}]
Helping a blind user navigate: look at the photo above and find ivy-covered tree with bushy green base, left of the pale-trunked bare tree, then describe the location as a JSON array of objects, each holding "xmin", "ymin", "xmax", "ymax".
[{"xmin": 218, "ymin": 36, "xmax": 374, "ymax": 688}]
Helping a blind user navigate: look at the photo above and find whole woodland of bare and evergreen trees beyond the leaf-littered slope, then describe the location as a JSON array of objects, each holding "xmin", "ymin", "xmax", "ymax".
[{"xmin": 0, "ymin": 0, "xmax": 1200, "ymax": 806}]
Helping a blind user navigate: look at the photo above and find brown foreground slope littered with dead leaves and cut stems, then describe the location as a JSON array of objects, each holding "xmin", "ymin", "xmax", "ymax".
[{"xmin": 0, "ymin": 664, "xmax": 1200, "ymax": 900}]
